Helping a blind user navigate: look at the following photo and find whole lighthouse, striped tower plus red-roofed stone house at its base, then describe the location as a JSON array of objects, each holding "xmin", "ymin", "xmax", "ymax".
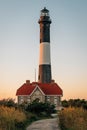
[{"xmin": 16, "ymin": 8, "xmax": 63, "ymax": 106}]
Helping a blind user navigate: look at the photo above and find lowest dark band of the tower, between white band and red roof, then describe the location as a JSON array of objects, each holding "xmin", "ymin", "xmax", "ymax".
[{"xmin": 38, "ymin": 65, "xmax": 51, "ymax": 83}]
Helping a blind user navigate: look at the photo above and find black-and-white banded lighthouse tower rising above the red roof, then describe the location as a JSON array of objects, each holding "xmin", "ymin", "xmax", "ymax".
[{"xmin": 38, "ymin": 8, "xmax": 51, "ymax": 83}]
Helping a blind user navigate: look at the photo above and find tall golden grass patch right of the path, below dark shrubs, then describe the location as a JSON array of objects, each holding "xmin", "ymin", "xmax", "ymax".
[{"xmin": 59, "ymin": 107, "xmax": 87, "ymax": 130}]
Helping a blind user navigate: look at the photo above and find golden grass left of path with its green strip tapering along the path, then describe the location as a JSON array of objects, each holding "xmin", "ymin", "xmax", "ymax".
[{"xmin": 0, "ymin": 106, "xmax": 51, "ymax": 130}]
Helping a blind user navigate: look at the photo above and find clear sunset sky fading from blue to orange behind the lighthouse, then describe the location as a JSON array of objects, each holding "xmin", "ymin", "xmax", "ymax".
[{"xmin": 0, "ymin": 0, "xmax": 87, "ymax": 100}]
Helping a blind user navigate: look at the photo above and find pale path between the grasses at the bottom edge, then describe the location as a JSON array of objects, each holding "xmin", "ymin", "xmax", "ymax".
[{"xmin": 26, "ymin": 118, "xmax": 60, "ymax": 130}]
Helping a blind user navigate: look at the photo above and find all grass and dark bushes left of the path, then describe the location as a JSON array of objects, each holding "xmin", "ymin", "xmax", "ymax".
[{"xmin": 0, "ymin": 99, "xmax": 56, "ymax": 130}]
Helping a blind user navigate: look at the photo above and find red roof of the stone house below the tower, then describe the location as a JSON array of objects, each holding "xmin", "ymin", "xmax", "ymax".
[{"xmin": 16, "ymin": 82, "xmax": 63, "ymax": 96}]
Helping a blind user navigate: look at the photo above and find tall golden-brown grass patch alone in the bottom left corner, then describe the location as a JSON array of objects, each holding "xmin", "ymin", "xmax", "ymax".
[{"xmin": 0, "ymin": 106, "xmax": 26, "ymax": 130}]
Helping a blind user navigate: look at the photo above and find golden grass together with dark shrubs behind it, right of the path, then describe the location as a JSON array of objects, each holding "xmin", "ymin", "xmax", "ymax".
[{"xmin": 59, "ymin": 99, "xmax": 87, "ymax": 130}]
